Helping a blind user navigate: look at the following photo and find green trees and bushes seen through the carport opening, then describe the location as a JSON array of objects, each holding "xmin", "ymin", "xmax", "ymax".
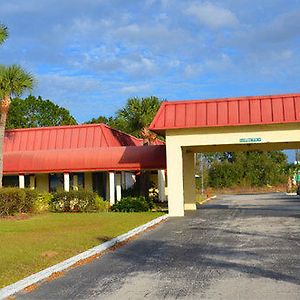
[{"xmin": 197, "ymin": 151, "xmax": 291, "ymax": 188}]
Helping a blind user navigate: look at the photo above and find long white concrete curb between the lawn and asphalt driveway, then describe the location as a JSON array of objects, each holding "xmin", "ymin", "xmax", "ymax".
[{"xmin": 0, "ymin": 215, "xmax": 168, "ymax": 299}]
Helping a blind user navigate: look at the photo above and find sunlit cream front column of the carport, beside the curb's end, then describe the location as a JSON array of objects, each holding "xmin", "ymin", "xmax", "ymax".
[{"xmin": 166, "ymin": 144, "xmax": 184, "ymax": 217}]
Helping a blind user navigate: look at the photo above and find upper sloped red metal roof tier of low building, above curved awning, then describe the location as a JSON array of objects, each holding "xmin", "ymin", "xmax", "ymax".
[{"xmin": 4, "ymin": 124, "xmax": 142, "ymax": 152}]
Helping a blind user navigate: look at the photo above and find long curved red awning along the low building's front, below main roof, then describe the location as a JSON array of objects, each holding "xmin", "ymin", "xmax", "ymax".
[{"xmin": 4, "ymin": 145, "xmax": 166, "ymax": 174}]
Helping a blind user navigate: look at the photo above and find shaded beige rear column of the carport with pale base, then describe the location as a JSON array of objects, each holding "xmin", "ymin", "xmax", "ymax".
[{"xmin": 183, "ymin": 153, "xmax": 197, "ymax": 210}]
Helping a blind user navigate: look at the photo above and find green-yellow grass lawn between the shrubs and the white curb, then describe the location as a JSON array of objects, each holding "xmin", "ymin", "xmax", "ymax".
[{"xmin": 0, "ymin": 212, "xmax": 162, "ymax": 288}]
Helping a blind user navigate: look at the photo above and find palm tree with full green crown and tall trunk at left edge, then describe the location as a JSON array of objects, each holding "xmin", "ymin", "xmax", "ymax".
[{"xmin": 0, "ymin": 65, "xmax": 34, "ymax": 188}]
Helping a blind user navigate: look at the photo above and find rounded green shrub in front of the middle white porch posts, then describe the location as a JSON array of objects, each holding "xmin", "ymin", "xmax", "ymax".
[{"xmin": 50, "ymin": 190, "xmax": 98, "ymax": 212}]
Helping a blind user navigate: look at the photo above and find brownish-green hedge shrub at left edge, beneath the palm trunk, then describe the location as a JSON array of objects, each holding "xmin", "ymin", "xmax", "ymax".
[{"xmin": 0, "ymin": 187, "xmax": 26, "ymax": 216}]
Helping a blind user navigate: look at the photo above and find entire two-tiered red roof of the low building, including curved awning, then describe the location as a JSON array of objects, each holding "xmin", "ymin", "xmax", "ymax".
[{"xmin": 3, "ymin": 124, "xmax": 166, "ymax": 174}]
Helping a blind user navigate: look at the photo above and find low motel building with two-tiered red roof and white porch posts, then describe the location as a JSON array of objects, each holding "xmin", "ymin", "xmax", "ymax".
[{"xmin": 3, "ymin": 124, "xmax": 166, "ymax": 204}]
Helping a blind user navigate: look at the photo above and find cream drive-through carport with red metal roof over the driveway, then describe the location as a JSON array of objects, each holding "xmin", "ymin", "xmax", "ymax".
[{"xmin": 150, "ymin": 94, "xmax": 300, "ymax": 216}]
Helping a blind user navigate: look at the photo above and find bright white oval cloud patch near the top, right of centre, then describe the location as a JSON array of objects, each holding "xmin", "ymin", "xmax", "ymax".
[{"xmin": 186, "ymin": 2, "xmax": 238, "ymax": 29}]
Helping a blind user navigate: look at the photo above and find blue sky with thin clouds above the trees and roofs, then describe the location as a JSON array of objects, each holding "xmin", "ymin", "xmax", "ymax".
[{"xmin": 0, "ymin": 0, "xmax": 300, "ymax": 122}]
